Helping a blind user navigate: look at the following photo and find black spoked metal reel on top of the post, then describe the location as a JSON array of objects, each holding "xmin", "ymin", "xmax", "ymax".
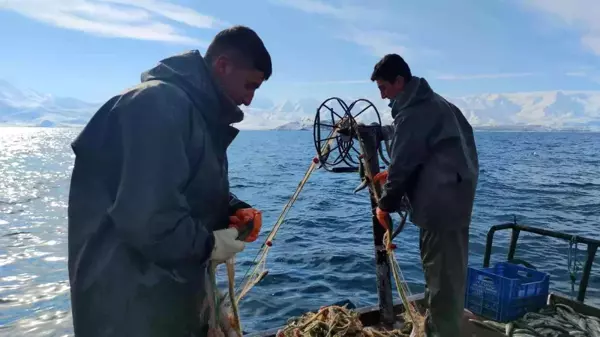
[{"xmin": 313, "ymin": 97, "xmax": 389, "ymax": 171}]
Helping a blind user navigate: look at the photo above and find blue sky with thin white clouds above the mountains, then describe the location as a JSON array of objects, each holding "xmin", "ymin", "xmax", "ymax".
[{"xmin": 0, "ymin": 0, "xmax": 600, "ymax": 102}]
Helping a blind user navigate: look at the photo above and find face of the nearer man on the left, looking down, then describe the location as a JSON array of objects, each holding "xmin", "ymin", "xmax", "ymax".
[{"xmin": 214, "ymin": 56, "xmax": 264, "ymax": 106}]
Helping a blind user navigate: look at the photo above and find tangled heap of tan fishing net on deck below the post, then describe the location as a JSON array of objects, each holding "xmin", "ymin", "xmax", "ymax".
[{"xmin": 277, "ymin": 306, "xmax": 412, "ymax": 337}]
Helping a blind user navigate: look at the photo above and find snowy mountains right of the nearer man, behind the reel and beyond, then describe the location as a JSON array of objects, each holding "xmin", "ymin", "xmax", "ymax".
[{"xmin": 242, "ymin": 91, "xmax": 600, "ymax": 131}]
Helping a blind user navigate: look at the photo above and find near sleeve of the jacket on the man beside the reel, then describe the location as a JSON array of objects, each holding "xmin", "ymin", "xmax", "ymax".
[{"xmin": 379, "ymin": 111, "xmax": 433, "ymax": 213}]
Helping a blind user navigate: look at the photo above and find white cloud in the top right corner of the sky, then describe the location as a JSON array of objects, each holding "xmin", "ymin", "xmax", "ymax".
[{"xmin": 524, "ymin": 0, "xmax": 600, "ymax": 55}]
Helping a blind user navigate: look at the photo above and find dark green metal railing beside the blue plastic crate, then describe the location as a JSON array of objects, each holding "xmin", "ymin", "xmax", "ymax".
[{"xmin": 483, "ymin": 219, "xmax": 600, "ymax": 303}]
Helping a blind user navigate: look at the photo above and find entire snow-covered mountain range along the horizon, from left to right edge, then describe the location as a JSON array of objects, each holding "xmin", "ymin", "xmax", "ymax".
[{"xmin": 0, "ymin": 80, "xmax": 600, "ymax": 130}]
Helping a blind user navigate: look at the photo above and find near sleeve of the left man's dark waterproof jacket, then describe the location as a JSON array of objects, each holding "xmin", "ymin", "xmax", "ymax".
[{"xmin": 109, "ymin": 86, "xmax": 214, "ymax": 266}]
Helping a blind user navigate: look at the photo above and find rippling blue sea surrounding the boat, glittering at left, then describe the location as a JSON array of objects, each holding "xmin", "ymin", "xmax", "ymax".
[{"xmin": 0, "ymin": 128, "xmax": 600, "ymax": 337}]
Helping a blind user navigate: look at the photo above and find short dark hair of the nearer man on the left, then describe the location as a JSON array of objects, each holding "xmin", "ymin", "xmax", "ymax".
[{"xmin": 204, "ymin": 25, "xmax": 273, "ymax": 80}]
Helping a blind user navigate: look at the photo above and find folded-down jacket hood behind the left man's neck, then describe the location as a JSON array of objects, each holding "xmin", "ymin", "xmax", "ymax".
[{"xmin": 141, "ymin": 50, "xmax": 244, "ymax": 125}]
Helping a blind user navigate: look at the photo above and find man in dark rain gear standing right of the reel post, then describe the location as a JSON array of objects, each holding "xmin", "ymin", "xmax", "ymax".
[{"xmin": 371, "ymin": 54, "xmax": 479, "ymax": 336}]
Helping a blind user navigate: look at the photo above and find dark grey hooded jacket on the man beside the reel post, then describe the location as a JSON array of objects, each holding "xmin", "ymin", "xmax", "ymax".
[{"xmin": 379, "ymin": 77, "xmax": 479, "ymax": 230}]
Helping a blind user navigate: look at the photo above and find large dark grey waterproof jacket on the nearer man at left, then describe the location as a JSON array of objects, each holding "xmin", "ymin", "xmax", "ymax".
[{"xmin": 68, "ymin": 51, "xmax": 249, "ymax": 337}]
